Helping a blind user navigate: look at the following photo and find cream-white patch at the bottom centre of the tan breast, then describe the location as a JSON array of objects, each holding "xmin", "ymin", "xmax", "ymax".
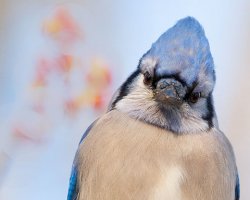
[{"xmin": 150, "ymin": 166, "xmax": 184, "ymax": 200}]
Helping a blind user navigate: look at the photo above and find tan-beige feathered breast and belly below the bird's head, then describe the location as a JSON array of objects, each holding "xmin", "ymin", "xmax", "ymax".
[{"xmin": 78, "ymin": 110, "xmax": 236, "ymax": 200}]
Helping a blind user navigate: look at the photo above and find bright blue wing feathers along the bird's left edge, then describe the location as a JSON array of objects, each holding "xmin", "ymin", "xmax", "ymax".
[{"xmin": 67, "ymin": 120, "xmax": 97, "ymax": 200}]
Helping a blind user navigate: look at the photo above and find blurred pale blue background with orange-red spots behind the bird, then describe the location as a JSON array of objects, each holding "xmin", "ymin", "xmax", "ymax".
[{"xmin": 0, "ymin": 0, "xmax": 250, "ymax": 200}]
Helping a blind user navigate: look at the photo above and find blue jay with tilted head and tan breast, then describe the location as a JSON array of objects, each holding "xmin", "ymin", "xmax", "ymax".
[{"xmin": 67, "ymin": 16, "xmax": 240, "ymax": 200}]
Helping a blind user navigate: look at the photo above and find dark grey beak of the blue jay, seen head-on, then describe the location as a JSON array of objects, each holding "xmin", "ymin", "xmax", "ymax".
[{"xmin": 155, "ymin": 78, "xmax": 186, "ymax": 105}]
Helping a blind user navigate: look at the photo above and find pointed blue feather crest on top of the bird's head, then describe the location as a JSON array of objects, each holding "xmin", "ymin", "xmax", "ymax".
[{"xmin": 146, "ymin": 17, "xmax": 214, "ymax": 85}]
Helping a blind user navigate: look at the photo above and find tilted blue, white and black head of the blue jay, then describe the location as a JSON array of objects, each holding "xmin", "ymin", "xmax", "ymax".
[{"xmin": 110, "ymin": 17, "xmax": 217, "ymax": 133}]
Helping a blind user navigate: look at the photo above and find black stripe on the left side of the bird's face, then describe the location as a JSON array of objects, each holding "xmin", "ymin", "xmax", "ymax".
[{"xmin": 111, "ymin": 69, "xmax": 140, "ymax": 110}]
